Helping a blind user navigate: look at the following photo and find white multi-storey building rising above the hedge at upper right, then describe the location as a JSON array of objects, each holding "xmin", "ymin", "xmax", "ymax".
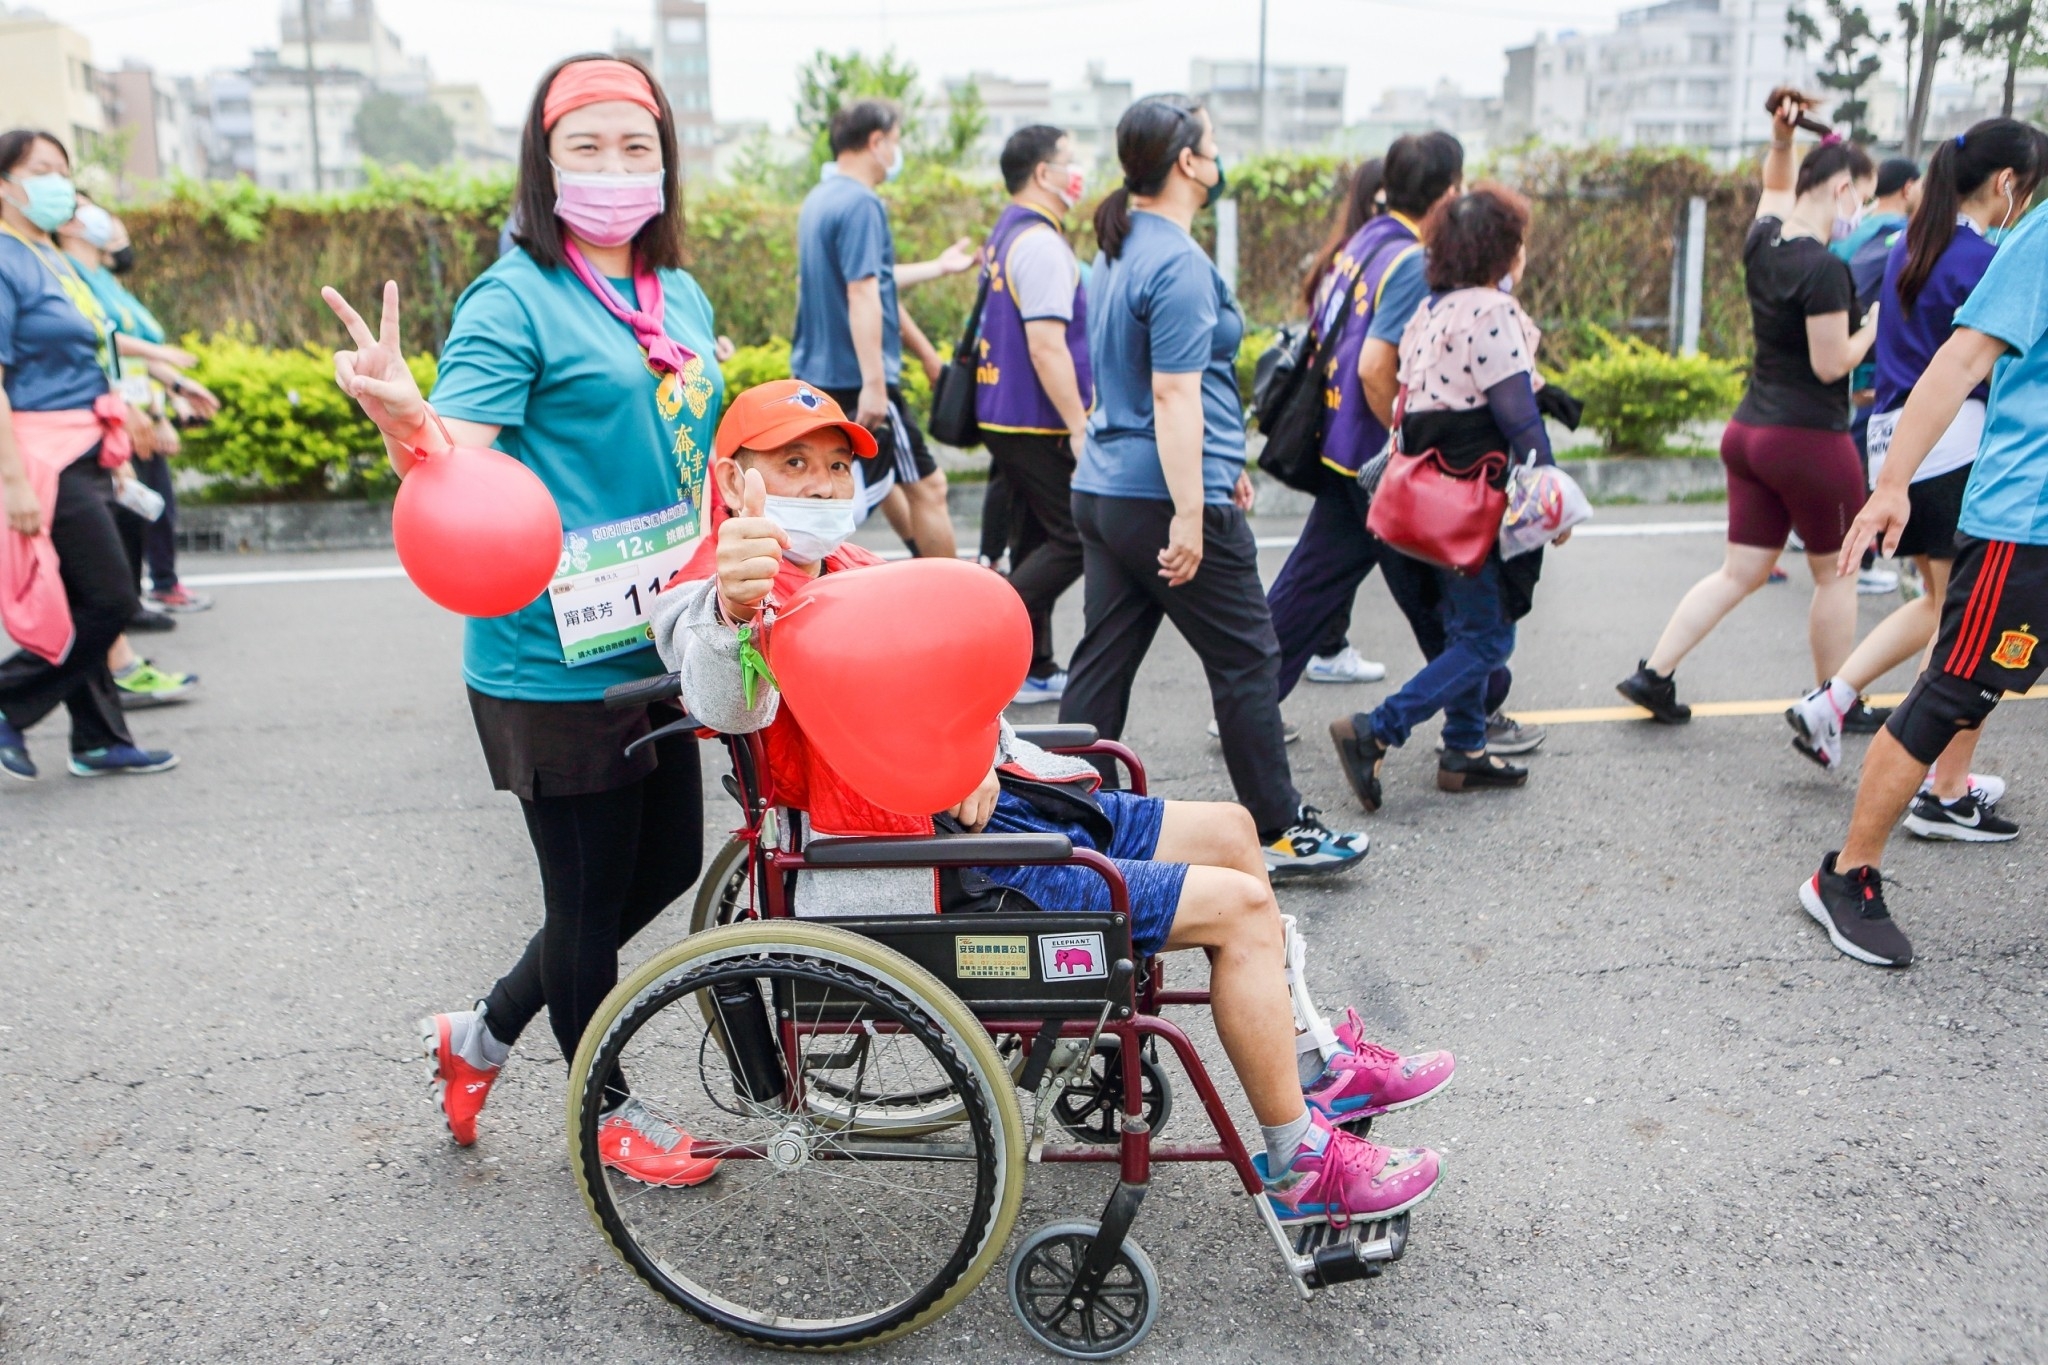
[{"xmin": 1501, "ymin": 0, "xmax": 1812, "ymax": 160}]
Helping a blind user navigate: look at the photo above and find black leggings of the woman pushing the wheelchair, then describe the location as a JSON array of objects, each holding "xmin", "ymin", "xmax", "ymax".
[{"xmin": 485, "ymin": 737, "xmax": 705, "ymax": 1060}]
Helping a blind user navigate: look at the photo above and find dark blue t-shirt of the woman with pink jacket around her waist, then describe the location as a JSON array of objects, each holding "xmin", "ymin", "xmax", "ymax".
[{"xmin": 0, "ymin": 231, "xmax": 106, "ymax": 411}]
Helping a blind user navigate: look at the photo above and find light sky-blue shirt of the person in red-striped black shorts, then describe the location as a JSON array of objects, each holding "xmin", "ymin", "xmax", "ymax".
[{"xmin": 1956, "ymin": 213, "xmax": 2048, "ymax": 544}]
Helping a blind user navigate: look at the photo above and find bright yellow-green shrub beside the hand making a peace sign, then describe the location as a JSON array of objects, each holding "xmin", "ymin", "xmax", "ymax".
[{"xmin": 178, "ymin": 334, "xmax": 434, "ymax": 499}]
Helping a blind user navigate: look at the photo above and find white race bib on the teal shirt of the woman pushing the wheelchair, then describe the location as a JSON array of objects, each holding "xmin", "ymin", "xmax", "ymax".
[{"xmin": 547, "ymin": 499, "xmax": 705, "ymax": 669}]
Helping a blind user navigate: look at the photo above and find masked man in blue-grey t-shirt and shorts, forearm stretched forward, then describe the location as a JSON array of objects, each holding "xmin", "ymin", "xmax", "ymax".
[{"xmin": 788, "ymin": 100, "xmax": 975, "ymax": 559}]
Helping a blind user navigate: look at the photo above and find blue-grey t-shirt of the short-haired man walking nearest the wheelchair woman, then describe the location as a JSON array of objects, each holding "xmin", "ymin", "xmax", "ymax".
[{"xmin": 788, "ymin": 166, "xmax": 903, "ymax": 389}]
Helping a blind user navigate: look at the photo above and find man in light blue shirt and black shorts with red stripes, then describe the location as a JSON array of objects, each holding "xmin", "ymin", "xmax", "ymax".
[{"xmin": 1800, "ymin": 202, "xmax": 2048, "ymax": 966}]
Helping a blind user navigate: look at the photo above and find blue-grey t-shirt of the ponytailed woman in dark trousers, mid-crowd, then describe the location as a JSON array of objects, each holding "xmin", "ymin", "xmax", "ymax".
[{"xmin": 1073, "ymin": 213, "xmax": 1245, "ymax": 503}]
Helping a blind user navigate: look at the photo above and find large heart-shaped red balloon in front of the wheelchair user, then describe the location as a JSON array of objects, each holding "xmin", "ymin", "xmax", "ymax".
[{"xmin": 768, "ymin": 559, "xmax": 1030, "ymax": 814}]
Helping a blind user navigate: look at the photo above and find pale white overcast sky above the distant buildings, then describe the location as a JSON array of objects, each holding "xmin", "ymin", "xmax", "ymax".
[{"xmin": 51, "ymin": 0, "xmax": 1646, "ymax": 127}]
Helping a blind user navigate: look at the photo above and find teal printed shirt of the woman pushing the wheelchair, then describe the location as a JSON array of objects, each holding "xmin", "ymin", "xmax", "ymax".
[{"xmin": 432, "ymin": 250, "xmax": 725, "ymax": 702}]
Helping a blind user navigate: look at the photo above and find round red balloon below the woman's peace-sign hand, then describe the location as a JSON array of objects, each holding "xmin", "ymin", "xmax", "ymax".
[{"xmin": 391, "ymin": 446, "xmax": 561, "ymax": 616}]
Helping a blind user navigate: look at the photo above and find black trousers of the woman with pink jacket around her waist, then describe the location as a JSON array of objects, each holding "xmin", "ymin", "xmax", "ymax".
[{"xmin": 0, "ymin": 446, "xmax": 137, "ymax": 753}]
